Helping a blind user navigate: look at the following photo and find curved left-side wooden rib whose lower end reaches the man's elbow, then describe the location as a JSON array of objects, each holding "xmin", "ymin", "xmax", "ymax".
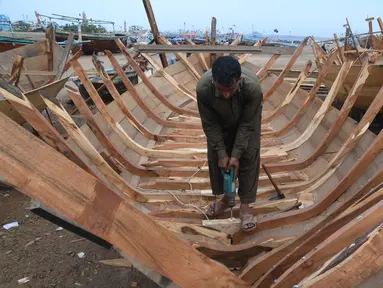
[{"xmin": 105, "ymin": 50, "xmax": 202, "ymax": 131}]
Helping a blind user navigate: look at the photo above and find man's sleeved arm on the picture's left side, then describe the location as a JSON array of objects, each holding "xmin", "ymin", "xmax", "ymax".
[{"xmin": 197, "ymin": 89, "xmax": 228, "ymax": 159}]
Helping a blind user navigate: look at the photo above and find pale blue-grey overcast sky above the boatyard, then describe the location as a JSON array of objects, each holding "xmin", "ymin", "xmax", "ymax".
[{"xmin": 0, "ymin": 0, "xmax": 383, "ymax": 37}]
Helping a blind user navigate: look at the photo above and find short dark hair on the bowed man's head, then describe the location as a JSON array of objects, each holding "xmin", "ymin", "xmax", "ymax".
[{"xmin": 212, "ymin": 56, "xmax": 241, "ymax": 86}]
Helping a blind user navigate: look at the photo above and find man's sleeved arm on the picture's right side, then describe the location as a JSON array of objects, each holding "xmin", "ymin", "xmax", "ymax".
[{"xmin": 231, "ymin": 84, "xmax": 263, "ymax": 159}]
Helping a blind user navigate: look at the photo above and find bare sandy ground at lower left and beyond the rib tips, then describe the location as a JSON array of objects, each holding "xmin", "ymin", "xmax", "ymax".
[{"xmin": 0, "ymin": 48, "xmax": 313, "ymax": 288}]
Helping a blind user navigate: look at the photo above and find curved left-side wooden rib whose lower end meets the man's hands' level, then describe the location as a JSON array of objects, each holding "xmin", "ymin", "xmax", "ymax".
[{"xmin": 71, "ymin": 61, "xmax": 206, "ymax": 158}]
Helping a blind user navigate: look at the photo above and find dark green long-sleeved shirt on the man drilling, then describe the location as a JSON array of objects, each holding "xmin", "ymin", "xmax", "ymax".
[{"xmin": 196, "ymin": 67, "xmax": 263, "ymax": 159}]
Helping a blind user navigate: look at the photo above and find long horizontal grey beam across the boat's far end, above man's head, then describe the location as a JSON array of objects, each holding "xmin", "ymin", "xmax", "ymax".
[{"xmin": 134, "ymin": 44, "xmax": 262, "ymax": 53}]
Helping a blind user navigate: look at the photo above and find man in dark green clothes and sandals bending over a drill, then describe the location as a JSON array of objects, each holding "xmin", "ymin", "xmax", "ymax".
[{"xmin": 197, "ymin": 56, "xmax": 263, "ymax": 231}]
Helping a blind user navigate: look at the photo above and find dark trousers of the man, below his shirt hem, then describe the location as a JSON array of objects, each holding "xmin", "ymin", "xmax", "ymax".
[{"xmin": 208, "ymin": 145, "xmax": 260, "ymax": 204}]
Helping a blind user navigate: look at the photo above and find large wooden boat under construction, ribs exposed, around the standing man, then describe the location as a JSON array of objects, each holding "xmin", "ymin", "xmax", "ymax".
[{"xmin": 0, "ymin": 32, "xmax": 383, "ymax": 288}]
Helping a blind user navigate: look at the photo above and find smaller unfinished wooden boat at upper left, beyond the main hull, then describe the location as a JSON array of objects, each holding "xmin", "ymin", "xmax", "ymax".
[{"xmin": 0, "ymin": 30, "xmax": 74, "ymax": 124}]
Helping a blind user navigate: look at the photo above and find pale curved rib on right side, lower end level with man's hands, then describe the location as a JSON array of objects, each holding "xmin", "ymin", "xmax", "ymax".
[{"xmin": 282, "ymin": 61, "xmax": 352, "ymax": 151}]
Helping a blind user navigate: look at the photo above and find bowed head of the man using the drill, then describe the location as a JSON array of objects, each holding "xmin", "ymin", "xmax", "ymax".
[{"xmin": 212, "ymin": 56, "xmax": 241, "ymax": 99}]
